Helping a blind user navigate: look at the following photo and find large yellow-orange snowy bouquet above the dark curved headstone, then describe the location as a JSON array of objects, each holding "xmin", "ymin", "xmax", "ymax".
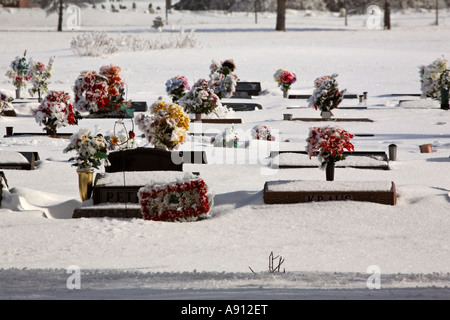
[{"xmin": 135, "ymin": 100, "xmax": 189, "ymax": 150}]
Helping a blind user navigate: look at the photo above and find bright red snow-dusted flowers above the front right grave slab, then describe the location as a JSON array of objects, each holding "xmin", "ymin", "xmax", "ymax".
[{"xmin": 306, "ymin": 126, "xmax": 355, "ymax": 169}]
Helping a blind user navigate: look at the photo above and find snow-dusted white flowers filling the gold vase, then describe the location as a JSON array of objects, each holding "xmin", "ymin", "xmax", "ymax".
[{"xmin": 63, "ymin": 128, "xmax": 109, "ymax": 171}]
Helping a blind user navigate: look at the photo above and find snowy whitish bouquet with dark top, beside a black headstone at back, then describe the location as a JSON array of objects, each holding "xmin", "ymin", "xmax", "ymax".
[{"xmin": 208, "ymin": 59, "xmax": 238, "ymax": 99}]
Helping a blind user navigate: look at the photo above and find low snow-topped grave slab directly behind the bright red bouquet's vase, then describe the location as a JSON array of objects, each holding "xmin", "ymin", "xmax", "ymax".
[{"xmin": 270, "ymin": 151, "xmax": 389, "ymax": 170}]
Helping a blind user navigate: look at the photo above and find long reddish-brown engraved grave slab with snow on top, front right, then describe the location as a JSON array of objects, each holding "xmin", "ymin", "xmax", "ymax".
[{"xmin": 264, "ymin": 180, "xmax": 397, "ymax": 205}]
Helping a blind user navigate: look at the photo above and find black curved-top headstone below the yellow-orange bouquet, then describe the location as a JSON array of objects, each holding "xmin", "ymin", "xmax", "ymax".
[{"xmin": 105, "ymin": 148, "xmax": 183, "ymax": 172}]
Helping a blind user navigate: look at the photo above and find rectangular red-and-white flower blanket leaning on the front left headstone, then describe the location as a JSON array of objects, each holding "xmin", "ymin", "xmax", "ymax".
[{"xmin": 138, "ymin": 174, "xmax": 213, "ymax": 221}]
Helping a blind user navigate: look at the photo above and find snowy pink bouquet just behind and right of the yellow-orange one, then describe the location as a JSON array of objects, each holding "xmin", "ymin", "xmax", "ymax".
[{"xmin": 178, "ymin": 79, "xmax": 221, "ymax": 114}]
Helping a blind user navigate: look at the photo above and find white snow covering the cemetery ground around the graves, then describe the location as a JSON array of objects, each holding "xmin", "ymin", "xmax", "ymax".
[{"xmin": 0, "ymin": 1, "xmax": 450, "ymax": 299}]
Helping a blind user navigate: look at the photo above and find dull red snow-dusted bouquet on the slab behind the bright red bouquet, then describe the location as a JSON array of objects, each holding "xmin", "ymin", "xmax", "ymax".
[{"xmin": 308, "ymin": 73, "xmax": 346, "ymax": 116}]
